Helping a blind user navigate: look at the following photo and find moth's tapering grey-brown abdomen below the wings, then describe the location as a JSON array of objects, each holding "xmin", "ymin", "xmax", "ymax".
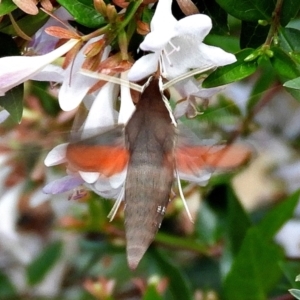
[{"xmin": 125, "ymin": 166, "xmax": 173, "ymax": 269}]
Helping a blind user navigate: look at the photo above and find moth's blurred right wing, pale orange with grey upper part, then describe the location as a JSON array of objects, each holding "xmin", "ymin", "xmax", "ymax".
[{"xmin": 175, "ymin": 128, "xmax": 251, "ymax": 183}]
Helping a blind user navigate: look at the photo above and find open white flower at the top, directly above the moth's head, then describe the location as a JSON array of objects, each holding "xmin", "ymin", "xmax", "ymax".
[{"xmin": 128, "ymin": 0, "xmax": 236, "ymax": 81}]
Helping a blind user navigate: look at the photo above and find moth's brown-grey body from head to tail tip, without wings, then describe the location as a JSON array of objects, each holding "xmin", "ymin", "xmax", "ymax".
[{"xmin": 125, "ymin": 79, "xmax": 176, "ymax": 269}]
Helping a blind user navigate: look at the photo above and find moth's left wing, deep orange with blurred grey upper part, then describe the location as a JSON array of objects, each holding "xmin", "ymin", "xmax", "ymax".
[{"xmin": 66, "ymin": 125, "xmax": 129, "ymax": 177}]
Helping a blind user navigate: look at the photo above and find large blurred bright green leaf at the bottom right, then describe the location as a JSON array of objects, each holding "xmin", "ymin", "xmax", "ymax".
[{"xmin": 222, "ymin": 228, "xmax": 284, "ymax": 300}]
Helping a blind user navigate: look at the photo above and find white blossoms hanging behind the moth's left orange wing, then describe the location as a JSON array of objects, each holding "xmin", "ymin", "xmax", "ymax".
[{"xmin": 44, "ymin": 76, "xmax": 135, "ymax": 198}]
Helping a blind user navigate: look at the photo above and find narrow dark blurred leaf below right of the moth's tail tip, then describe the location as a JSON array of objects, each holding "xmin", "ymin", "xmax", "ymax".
[{"xmin": 151, "ymin": 248, "xmax": 193, "ymax": 300}]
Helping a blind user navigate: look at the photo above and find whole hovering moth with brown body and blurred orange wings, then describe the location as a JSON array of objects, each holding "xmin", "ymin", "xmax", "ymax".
[{"xmin": 66, "ymin": 77, "xmax": 251, "ymax": 269}]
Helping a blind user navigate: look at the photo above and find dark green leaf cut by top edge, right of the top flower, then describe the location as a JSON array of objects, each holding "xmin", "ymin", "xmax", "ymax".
[{"xmin": 216, "ymin": 0, "xmax": 275, "ymax": 22}]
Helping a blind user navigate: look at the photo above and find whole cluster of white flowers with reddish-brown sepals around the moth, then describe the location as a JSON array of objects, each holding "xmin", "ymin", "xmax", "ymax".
[{"xmin": 0, "ymin": 0, "xmax": 236, "ymax": 202}]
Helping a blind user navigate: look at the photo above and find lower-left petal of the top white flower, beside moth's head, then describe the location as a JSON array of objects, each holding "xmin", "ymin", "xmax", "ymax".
[{"xmin": 128, "ymin": 52, "xmax": 160, "ymax": 81}]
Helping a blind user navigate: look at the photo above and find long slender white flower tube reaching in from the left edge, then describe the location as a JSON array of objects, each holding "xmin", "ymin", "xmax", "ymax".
[{"xmin": 0, "ymin": 39, "xmax": 79, "ymax": 96}]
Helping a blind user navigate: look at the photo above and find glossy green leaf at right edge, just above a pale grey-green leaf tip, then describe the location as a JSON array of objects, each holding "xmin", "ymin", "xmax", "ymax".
[{"xmin": 270, "ymin": 47, "xmax": 300, "ymax": 79}]
